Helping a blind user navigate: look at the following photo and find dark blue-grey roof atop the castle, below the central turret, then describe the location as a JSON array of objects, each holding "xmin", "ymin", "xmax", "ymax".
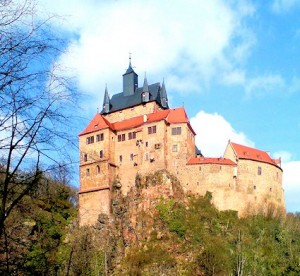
[{"xmin": 102, "ymin": 83, "xmax": 169, "ymax": 113}]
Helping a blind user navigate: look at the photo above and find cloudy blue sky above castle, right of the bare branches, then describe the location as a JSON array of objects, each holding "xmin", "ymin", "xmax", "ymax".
[{"xmin": 40, "ymin": 0, "xmax": 300, "ymax": 212}]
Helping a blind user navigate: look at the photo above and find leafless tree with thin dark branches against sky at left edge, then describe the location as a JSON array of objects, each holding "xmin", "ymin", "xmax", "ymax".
[{"xmin": 0, "ymin": 0, "xmax": 76, "ymax": 238}]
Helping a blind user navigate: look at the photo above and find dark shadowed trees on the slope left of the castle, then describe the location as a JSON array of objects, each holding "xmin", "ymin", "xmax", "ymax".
[{"xmin": 0, "ymin": 176, "xmax": 77, "ymax": 275}]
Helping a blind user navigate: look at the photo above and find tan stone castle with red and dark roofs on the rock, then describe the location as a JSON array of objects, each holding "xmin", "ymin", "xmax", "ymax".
[{"xmin": 79, "ymin": 61, "xmax": 285, "ymax": 225}]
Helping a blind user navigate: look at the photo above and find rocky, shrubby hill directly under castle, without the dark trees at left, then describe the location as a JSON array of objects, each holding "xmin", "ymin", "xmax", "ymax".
[{"xmin": 68, "ymin": 171, "xmax": 300, "ymax": 275}]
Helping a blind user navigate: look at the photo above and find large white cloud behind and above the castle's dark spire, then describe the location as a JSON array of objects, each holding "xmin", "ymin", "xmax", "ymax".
[{"xmin": 40, "ymin": 0, "xmax": 254, "ymax": 112}]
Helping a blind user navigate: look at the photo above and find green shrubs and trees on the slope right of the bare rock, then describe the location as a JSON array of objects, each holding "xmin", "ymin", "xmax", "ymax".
[{"xmin": 157, "ymin": 194, "xmax": 300, "ymax": 275}]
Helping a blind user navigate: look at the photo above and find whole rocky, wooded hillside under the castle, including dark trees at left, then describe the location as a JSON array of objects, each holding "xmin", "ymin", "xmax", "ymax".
[{"xmin": 0, "ymin": 171, "xmax": 300, "ymax": 276}]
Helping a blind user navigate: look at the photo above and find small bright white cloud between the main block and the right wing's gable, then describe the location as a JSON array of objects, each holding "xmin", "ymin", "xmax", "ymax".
[{"xmin": 190, "ymin": 111, "xmax": 254, "ymax": 157}]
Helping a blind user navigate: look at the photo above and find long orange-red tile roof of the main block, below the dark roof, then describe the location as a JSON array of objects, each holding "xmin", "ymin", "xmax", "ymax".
[{"xmin": 79, "ymin": 107, "xmax": 196, "ymax": 136}]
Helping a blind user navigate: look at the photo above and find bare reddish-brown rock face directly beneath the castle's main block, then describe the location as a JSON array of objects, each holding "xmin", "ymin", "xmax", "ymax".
[{"xmin": 112, "ymin": 171, "xmax": 184, "ymax": 247}]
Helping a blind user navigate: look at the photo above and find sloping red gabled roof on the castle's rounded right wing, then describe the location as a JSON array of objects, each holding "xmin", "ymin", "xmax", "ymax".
[{"xmin": 230, "ymin": 142, "xmax": 278, "ymax": 166}]
